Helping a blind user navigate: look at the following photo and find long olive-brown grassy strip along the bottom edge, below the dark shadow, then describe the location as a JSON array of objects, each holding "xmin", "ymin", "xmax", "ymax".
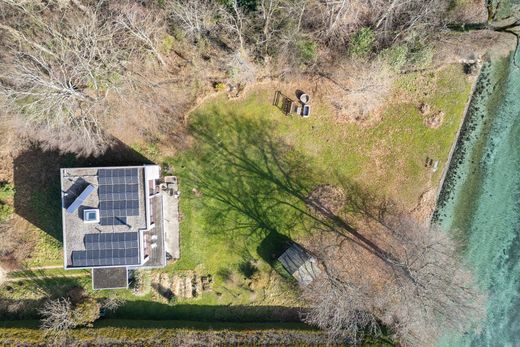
[{"xmin": 0, "ymin": 320, "xmax": 393, "ymax": 347}]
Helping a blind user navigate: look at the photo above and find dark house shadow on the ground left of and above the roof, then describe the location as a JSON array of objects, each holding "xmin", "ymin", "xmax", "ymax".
[{"xmin": 14, "ymin": 139, "xmax": 151, "ymax": 242}]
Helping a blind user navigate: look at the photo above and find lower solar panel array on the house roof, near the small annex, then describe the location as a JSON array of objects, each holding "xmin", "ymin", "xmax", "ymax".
[{"xmin": 72, "ymin": 232, "xmax": 139, "ymax": 267}]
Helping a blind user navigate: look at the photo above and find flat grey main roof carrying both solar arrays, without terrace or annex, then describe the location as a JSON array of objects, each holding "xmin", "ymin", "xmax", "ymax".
[{"xmin": 61, "ymin": 166, "xmax": 147, "ymax": 268}]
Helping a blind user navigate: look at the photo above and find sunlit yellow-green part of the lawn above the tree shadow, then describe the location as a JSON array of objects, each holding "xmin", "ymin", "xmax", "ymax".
[{"xmin": 174, "ymin": 65, "xmax": 471, "ymax": 209}]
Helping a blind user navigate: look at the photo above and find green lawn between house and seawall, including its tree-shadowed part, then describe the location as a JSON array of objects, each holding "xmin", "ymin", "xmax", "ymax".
[{"xmin": 167, "ymin": 65, "xmax": 471, "ymax": 282}]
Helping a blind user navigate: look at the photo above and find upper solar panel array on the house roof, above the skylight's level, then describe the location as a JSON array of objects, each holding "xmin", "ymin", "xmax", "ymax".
[{"xmin": 98, "ymin": 168, "xmax": 139, "ymax": 225}]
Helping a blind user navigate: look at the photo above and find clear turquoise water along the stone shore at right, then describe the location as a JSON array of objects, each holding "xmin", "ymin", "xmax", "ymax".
[{"xmin": 438, "ymin": 47, "xmax": 520, "ymax": 346}]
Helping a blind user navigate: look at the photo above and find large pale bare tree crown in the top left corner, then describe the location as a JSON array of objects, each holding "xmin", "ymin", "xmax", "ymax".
[{"xmin": 0, "ymin": 0, "xmax": 132, "ymax": 152}]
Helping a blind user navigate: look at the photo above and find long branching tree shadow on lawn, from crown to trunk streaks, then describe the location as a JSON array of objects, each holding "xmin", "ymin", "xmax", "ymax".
[{"xmin": 184, "ymin": 109, "xmax": 412, "ymax": 278}]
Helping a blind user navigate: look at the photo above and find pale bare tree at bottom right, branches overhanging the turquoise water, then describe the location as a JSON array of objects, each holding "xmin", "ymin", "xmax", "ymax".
[{"xmin": 383, "ymin": 222, "xmax": 485, "ymax": 345}]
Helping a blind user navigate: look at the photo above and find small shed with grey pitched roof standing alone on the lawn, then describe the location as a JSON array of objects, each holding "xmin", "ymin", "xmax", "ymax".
[{"xmin": 278, "ymin": 243, "xmax": 320, "ymax": 286}]
